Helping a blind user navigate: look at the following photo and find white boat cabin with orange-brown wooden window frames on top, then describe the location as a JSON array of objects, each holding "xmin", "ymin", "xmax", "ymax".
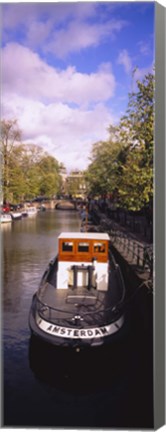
[{"xmin": 57, "ymin": 232, "xmax": 110, "ymax": 291}]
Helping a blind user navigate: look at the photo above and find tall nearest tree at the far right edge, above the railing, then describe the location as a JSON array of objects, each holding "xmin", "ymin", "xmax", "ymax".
[{"xmin": 119, "ymin": 73, "xmax": 154, "ymax": 210}]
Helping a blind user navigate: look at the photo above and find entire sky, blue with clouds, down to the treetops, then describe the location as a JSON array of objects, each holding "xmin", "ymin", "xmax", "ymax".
[{"xmin": 1, "ymin": 1, "xmax": 155, "ymax": 171}]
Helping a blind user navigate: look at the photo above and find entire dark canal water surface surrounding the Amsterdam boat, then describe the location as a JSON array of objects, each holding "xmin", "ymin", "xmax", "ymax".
[{"xmin": 1, "ymin": 210, "xmax": 153, "ymax": 429}]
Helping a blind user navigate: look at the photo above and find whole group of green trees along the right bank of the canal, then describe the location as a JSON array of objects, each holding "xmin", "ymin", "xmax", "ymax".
[{"xmin": 86, "ymin": 73, "xmax": 154, "ymax": 210}]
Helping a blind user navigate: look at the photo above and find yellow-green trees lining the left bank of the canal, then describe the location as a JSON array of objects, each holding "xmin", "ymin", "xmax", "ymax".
[{"xmin": 1, "ymin": 120, "xmax": 61, "ymax": 203}]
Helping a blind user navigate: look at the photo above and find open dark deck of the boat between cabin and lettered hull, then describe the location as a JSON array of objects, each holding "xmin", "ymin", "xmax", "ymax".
[{"xmin": 38, "ymin": 270, "xmax": 124, "ymax": 327}]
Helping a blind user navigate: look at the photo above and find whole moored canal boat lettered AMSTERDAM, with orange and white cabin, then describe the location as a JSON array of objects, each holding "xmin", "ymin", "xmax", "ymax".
[{"xmin": 29, "ymin": 232, "xmax": 125, "ymax": 349}]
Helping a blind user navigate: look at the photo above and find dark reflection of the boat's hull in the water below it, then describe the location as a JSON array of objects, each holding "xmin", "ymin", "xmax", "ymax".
[{"xmin": 29, "ymin": 336, "xmax": 135, "ymax": 394}]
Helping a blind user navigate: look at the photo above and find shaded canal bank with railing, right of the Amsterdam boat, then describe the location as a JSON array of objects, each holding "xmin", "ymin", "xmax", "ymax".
[{"xmin": 90, "ymin": 204, "xmax": 154, "ymax": 342}]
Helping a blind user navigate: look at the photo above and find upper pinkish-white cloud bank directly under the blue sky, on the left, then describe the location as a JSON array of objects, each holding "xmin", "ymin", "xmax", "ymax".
[{"xmin": 2, "ymin": 43, "xmax": 116, "ymax": 105}]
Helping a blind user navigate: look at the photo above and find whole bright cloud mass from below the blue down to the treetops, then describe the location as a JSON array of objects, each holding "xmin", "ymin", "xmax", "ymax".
[{"xmin": 2, "ymin": 44, "xmax": 118, "ymax": 169}]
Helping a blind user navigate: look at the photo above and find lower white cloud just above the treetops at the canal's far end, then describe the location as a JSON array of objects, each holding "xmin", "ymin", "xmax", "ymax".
[{"xmin": 2, "ymin": 94, "xmax": 114, "ymax": 174}]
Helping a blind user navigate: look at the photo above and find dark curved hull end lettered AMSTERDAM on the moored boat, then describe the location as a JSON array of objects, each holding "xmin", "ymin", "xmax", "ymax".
[{"xmin": 29, "ymin": 294, "xmax": 128, "ymax": 349}]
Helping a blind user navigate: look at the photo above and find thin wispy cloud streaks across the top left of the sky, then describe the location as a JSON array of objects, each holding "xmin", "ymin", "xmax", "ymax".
[{"xmin": 3, "ymin": 2, "xmax": 127, "ymax": 58}]
